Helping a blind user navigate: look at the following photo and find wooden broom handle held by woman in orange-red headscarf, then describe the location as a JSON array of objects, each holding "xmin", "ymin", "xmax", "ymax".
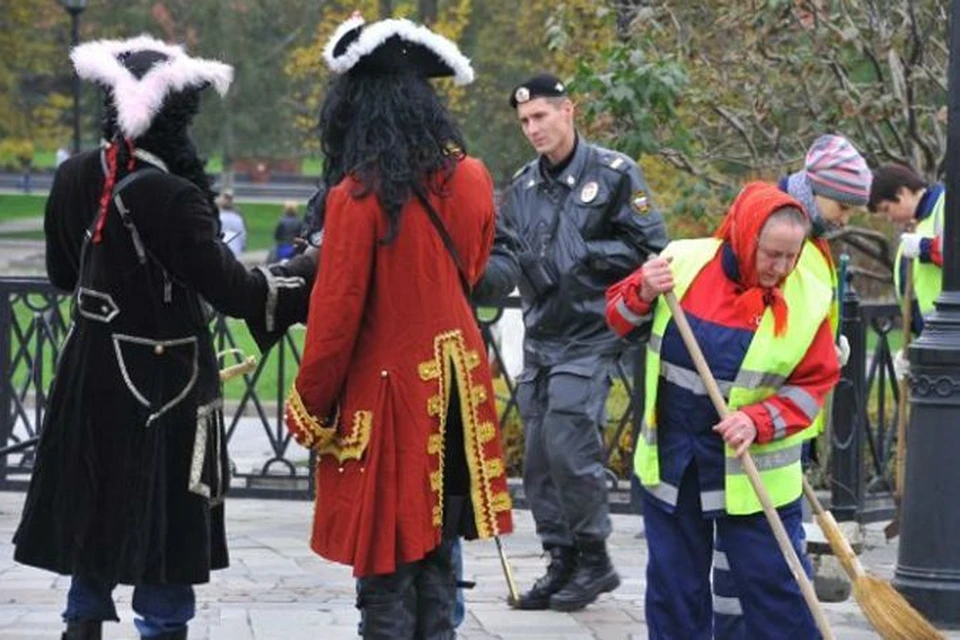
[{"xmin": 663, "ymin": 291, "xmax": 835, "ymax": 640}]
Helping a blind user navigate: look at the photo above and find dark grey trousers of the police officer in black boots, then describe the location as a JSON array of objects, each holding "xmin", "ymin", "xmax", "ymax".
[{"xmin": 517, "ymin": 356, "xmax": 614, "ymax": 547}]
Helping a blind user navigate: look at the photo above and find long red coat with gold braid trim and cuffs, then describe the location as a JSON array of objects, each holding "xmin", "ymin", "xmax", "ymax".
[{"xmin": 287, "ymin": 158, "xmax": 512, "ymax": 576}]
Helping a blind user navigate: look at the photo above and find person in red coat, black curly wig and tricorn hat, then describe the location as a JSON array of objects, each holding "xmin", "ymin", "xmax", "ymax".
[{"xmin": 286, "ymin": 17, "xmax": 512, "ymax": 638}]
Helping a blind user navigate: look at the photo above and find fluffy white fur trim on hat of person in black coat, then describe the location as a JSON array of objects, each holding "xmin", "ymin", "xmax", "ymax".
[{"xmin": 70, "ymin": 35, "xmax": 233, "ymax": 138}]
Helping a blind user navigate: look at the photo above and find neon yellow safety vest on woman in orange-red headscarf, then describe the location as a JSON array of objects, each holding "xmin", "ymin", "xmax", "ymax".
[{"xmin": 633, "ymin": 238, "xmax": 831, "ymax": 515}]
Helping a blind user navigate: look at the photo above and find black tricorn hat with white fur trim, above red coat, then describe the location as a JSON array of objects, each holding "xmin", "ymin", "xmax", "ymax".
[{"xmin": 323, "ymin": 15, "xmax": 473, "ymax": 85}]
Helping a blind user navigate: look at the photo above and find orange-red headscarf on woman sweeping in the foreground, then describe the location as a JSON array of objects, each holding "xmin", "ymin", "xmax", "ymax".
[{"xmin": 714, "ymin": 182, "xmax": 803, "ymax": 336}]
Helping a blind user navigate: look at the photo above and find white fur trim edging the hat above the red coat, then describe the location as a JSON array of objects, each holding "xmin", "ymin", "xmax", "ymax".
[{"xmin": 323, "ymin": 18, "xmax": 473, "ymax": 85}]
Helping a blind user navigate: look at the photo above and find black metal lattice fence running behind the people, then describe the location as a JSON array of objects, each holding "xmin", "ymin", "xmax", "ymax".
[{"xmin": 0, "ymin": 277, "xmax": 900, "ymax": 521}]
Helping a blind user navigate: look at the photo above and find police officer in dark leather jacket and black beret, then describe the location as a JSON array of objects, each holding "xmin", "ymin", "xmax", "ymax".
[{"xmin": 476, "ymin": 73, "xmax": 667, "ymax": 611}]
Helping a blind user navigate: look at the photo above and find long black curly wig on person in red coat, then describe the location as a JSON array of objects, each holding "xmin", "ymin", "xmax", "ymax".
[{"xmin": 319, "ymin": 73, "xmax": 466, "ymax": 243}]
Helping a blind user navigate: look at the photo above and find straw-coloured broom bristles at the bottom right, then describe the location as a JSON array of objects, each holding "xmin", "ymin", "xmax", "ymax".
[{"xmin": 853, "ymin": 574, "xmax": 945, "ymax": 640}]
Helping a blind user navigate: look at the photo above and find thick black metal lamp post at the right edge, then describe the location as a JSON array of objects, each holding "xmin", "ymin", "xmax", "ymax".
[{"xmin": 894, "ymin": 0, "xmax": 960, "ymax": 627}]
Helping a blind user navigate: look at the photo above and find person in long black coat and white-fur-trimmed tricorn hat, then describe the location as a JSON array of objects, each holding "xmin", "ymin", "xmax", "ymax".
[{"xmin": 14, "ymin": 36, "xmax": 316, "ymax": 640}]
